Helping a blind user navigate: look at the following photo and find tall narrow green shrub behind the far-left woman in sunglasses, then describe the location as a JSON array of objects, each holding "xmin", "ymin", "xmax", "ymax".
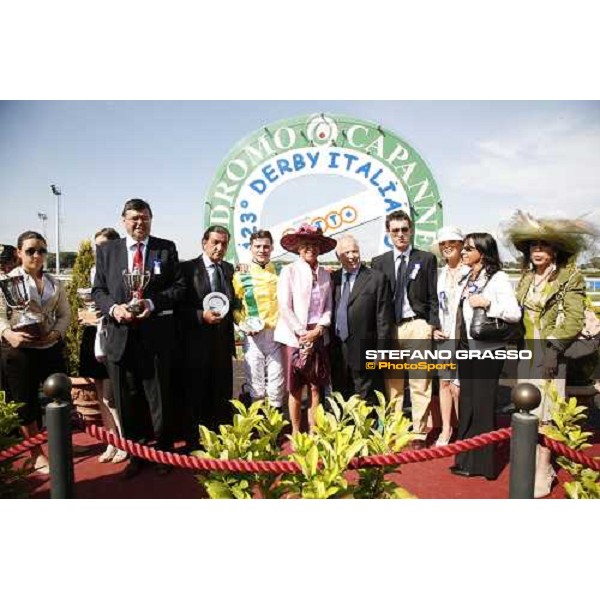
[{"xmin": 65, "ymin": 240, "xmax": 94, "ymax": 377}]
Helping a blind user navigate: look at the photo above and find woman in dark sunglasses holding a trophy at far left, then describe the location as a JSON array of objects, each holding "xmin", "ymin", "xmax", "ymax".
[{"xmin": 0, "ymin": 231, "xmax": 71, "ymax": 474}]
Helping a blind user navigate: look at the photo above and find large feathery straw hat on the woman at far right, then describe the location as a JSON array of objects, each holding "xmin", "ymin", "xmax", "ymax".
[{"xmin": 503, "ymin": 210, "xmax": 598, "ymax": 256}]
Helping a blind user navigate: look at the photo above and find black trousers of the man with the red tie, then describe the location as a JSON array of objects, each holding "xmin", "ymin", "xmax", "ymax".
[{"xmin": 107, "ymin": 328, "xmax": 173, "ymax": 450}]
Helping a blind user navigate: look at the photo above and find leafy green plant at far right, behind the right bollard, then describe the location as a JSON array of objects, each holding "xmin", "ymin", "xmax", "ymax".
[{"xmin": 541, "ymin": 382, "xmax": 600, "ymax": 500}]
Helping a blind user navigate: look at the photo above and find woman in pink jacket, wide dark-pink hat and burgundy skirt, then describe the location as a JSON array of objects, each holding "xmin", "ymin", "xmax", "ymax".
[{"xmin": 275, "ymin": 224, "xmax": 336, "ymax": 433}]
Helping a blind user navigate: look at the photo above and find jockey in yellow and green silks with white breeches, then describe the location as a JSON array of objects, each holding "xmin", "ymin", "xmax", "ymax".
[{"xmin": 233, "ymin": 230, "xmax": 285, "ymax": 408}]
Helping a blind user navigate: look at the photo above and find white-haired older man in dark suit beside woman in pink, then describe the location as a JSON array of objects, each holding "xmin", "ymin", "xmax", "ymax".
[{"xmin": 331, "ymin": 235, "xmax": 394, "ymax": 403}]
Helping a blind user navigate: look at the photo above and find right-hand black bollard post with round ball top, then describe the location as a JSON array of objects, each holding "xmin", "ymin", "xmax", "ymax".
[{"xmin": 508, "ymin": 383, "xmax": 541, "ymax": 499}]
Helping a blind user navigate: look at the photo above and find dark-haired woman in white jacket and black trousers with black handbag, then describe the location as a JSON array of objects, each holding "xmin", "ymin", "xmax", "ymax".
[{"xmin": 450, "ymin": 233, "xmax": 521, "ymax": 479}]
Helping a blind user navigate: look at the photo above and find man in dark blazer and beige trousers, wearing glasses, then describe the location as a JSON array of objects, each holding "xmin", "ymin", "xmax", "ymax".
[{"xmin": 373, "ymin": 210, "xmax": 440, "ymax": 445}]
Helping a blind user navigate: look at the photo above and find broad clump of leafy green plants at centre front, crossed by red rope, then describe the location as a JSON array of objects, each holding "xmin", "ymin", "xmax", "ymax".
[{"xmin": 199, "ymin": 393, "xmax": 413, "ymax": 499}]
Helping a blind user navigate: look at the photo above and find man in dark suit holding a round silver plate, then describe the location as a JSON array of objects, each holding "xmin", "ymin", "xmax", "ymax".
[{"xmin": 177, "ymin": 225, "xmax": 235, "ymax": 450}]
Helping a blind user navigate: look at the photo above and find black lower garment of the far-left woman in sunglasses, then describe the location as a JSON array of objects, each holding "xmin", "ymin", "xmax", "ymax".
[{"xmin": 1, "ymin": 342, "xmax": 67, "ymax": 425}]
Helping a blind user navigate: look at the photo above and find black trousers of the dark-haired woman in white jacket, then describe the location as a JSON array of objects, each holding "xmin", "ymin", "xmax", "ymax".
[{"xmin": 455, "ymin": 359, "xmax": 504, "ymax": 479}]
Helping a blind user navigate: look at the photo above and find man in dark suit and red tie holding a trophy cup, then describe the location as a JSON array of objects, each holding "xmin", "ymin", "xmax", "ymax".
[{"xmin": 92, "ymin": 198, "xmax": 185, "ymax": 477}]
